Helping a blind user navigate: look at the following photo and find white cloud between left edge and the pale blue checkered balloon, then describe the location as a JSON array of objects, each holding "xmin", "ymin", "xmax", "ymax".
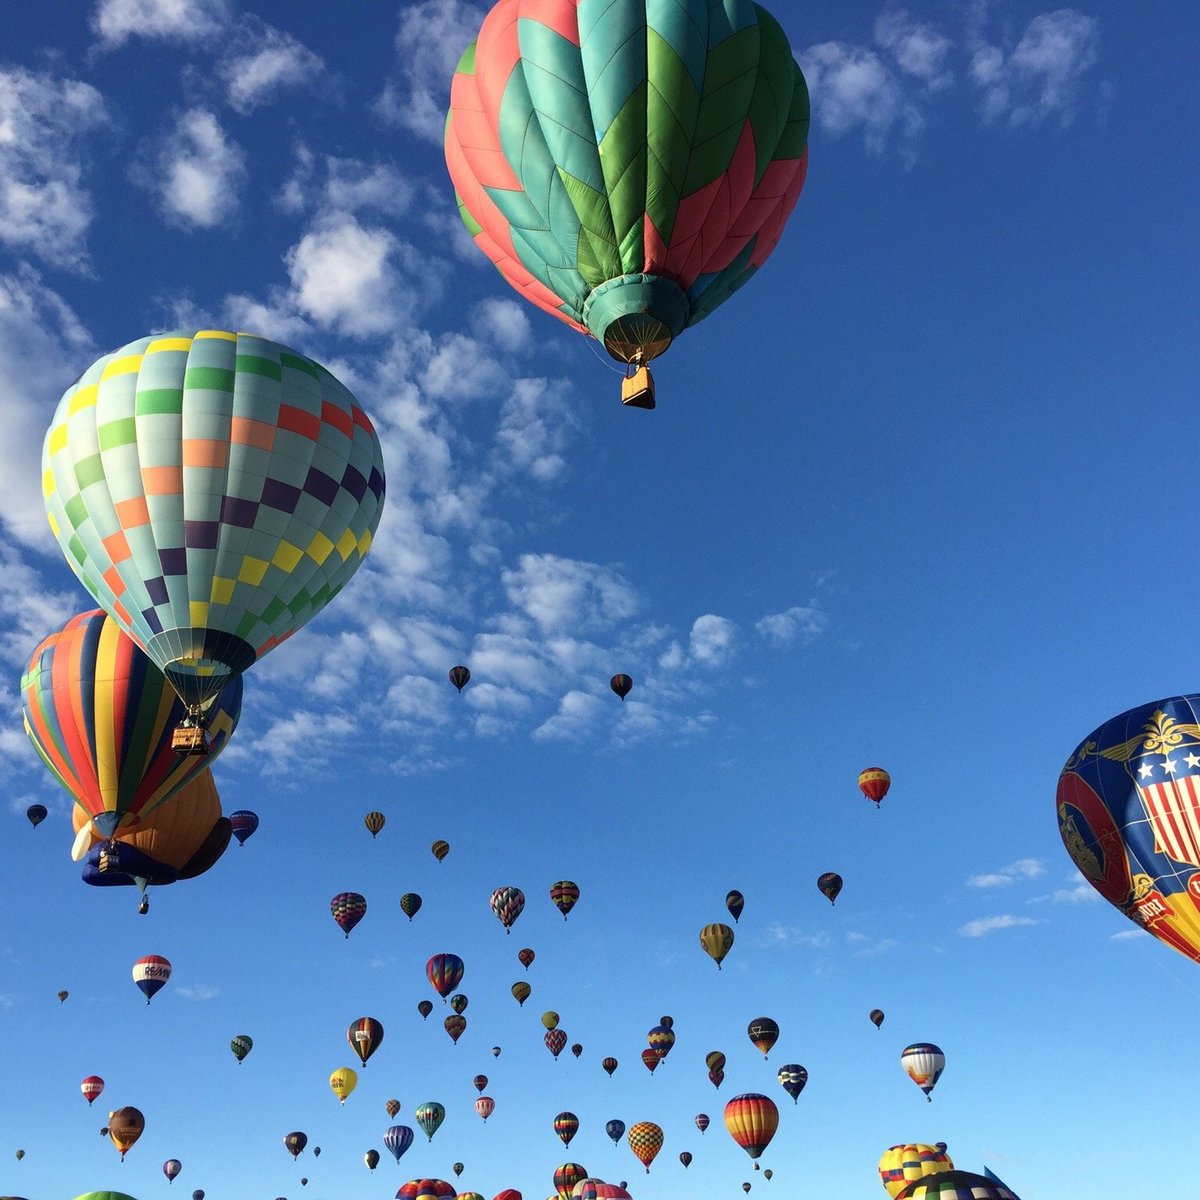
[{"xmin": 0, "ymin": 266, "xmax": 95, "ymax": 551}]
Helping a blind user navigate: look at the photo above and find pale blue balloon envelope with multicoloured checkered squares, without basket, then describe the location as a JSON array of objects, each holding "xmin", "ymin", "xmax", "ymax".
[{"xmin": 42, "ymin": 330, "xmax": 384, "ymax": 704}]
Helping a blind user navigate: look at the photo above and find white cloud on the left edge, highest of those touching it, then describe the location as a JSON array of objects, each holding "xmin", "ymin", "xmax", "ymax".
[{"xmin": 0, "ymin": 67, "xmax": 108, "ymax": 270}]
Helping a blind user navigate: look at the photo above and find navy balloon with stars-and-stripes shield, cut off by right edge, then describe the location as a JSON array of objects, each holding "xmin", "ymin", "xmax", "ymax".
[{"xmin": 1057, "ymin": 695, "xmax": 1200, "ymax": 962}]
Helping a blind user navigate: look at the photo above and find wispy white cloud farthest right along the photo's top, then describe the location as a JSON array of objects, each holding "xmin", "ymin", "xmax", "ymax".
[{"xmin": 971, "ymin": 8, "xmax": 1100, "ymax": 128}]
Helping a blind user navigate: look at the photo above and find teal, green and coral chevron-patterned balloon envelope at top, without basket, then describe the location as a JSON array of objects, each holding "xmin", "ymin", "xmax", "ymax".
[{"xmin": 445, "ymin": 0, "xmax": 809, "ymax": 362}]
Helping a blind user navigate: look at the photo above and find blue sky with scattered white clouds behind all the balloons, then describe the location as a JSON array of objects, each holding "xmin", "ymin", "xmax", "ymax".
[{"xmin": 0, "ymin": 0, "xmax": 1200, "ymax": 1200}]
